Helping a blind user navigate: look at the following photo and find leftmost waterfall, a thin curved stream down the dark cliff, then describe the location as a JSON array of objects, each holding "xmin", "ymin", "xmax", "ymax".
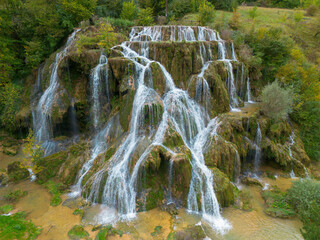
[{"xmin": 33, "ymin": 29, "xmax": 80, "ymax": 156}]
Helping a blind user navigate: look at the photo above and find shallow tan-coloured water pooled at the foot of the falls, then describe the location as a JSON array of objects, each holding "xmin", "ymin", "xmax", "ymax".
[{"xmin": 0, "ymin": 174, "xmax": 303, "ymax": 240}]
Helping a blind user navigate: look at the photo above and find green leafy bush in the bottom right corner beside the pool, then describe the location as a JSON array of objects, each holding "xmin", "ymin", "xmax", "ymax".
[{"xmin": 288, "ymin": 179, "xmax": 320, "ymax": 240}]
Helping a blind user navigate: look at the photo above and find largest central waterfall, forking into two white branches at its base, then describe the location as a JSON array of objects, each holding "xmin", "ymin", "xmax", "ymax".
[{"xmin": 87, "ymin": 26, "xmax": 231, "ymax": 233}]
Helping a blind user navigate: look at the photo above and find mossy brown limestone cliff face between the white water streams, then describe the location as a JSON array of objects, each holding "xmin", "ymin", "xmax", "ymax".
[{"xmin": 19, "ymin": 26, "xmax": 310, "ymax": 211}]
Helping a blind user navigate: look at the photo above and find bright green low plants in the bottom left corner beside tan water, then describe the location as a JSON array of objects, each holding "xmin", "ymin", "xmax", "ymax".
[{"xmin": 0, "ymin": 212, "xmax": 41, "ymax": 240}]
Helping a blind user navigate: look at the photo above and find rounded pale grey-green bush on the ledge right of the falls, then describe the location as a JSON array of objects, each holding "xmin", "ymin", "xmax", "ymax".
[{"xmin": 260, "ymin": 81, "xmax": 293, "ymax": 121}]
